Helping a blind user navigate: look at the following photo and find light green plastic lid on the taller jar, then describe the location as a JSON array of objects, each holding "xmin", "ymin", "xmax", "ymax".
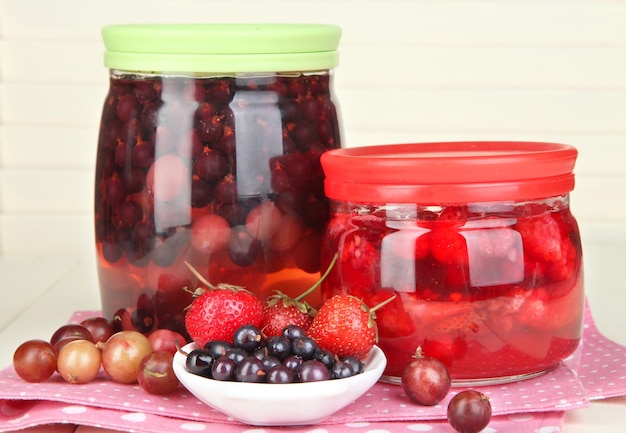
[{"xmin": 102, "ymin": 24, "xmax": 341, "ymax": 73}]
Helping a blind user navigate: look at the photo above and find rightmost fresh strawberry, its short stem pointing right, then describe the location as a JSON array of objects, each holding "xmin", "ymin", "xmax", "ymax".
[{"xmin": 308, "ymin": 295, "xmax": 395, "ymax": 359}]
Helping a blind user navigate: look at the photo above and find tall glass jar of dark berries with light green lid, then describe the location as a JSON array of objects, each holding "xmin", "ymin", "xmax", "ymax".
[{"xmin": 95, "ymin": 24, "xmax": 341, "ymax": 332}]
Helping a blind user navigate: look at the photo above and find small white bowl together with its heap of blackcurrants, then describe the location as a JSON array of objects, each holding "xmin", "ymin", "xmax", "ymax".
[{"xmin": 173, "ymin": 326, "xmax": 387, "ymax": 426}]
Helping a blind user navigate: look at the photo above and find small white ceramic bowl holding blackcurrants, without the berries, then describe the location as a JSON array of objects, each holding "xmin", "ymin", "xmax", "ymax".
[{"xmin": 173, "ymin": 343, "xmax": 387, "ymax": 426}]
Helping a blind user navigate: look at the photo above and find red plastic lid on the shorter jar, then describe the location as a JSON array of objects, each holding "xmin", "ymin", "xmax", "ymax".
[{"xmin": 321, "ymin": 141, "xmax": 578, "ymax": 204}]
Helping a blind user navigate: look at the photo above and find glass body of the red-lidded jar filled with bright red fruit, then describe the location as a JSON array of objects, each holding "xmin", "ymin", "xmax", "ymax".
[{"xmin": 322, "ymin": 194, "xmax": 584, "ymax": 382}]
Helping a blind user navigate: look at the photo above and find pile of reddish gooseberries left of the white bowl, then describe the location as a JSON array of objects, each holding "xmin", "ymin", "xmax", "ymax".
[{"xmin": 13, "ymin": 317, "xmax": 184, "ymax": 395}]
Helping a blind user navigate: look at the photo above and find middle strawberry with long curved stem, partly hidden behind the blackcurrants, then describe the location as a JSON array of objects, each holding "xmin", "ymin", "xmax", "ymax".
[{"xmin": 261, "ymin": 251, "xmax": 338, "ymax": 337}]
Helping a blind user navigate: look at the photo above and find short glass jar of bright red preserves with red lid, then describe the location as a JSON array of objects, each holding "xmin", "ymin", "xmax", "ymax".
[{"xmin": 322, "ymin": 142, "xmax": 584, "ymax": 384}]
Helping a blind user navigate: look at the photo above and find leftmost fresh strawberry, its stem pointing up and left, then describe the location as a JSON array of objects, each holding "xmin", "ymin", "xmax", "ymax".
[{"xmin": 185, "ymin": 258, "xmax": 263, "ymax": 346}]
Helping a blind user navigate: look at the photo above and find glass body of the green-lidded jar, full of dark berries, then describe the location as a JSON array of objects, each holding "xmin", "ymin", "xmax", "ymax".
[{"xmin": 95, "ymin": 71, "xmax": 340, "ymax": 332}]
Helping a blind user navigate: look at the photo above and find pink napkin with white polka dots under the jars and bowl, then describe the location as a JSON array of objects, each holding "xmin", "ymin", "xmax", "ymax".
[{"xmin": 0, "ymin": 300, "xmax": 626, "ymax": 433}]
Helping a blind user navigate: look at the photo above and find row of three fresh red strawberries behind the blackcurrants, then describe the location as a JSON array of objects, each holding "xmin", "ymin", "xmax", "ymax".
[{"xmin": 180, "ymin": 256, "xmax": 386, "ymax": 359}]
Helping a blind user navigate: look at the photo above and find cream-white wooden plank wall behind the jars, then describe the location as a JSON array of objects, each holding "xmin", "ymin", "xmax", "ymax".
[{"xmin": 0, "ymin": 0, "xmax": 626, "ymax": 256}]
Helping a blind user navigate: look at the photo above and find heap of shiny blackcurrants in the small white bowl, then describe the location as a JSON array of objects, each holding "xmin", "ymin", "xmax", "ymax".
[{"xmin": 186, "ymin": 325, "xmax": 364, "ymax": 384}]
